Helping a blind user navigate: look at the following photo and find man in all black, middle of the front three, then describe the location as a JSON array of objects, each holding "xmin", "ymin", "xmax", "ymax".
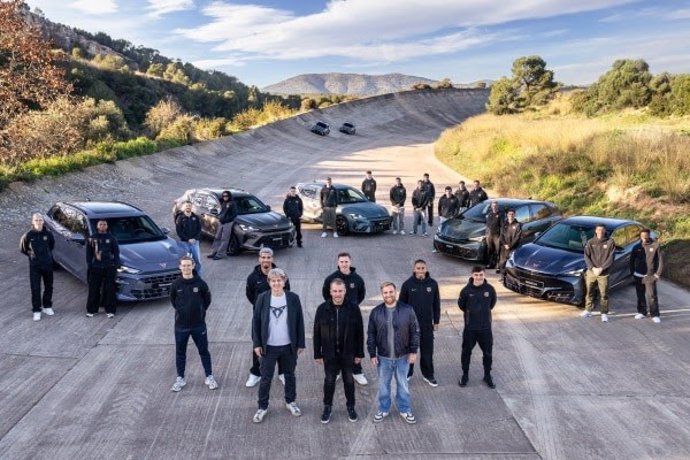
[{"xmin": 313, "ymin": 278, "xmax": 364, "ymax": 423}]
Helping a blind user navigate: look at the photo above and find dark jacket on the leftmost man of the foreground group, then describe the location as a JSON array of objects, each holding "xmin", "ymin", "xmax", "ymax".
[{"xmin": 170, "ymin": 273, "xmax": 211, "ymax": 328}]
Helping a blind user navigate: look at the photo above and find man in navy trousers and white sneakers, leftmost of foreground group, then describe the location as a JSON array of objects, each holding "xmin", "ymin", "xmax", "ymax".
[{"xmin": 170, "ymin": 256, "xmax": 218, "ymax": 392}]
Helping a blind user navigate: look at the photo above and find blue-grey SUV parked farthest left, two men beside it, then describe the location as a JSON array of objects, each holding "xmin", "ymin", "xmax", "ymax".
[{"xmin": 45, "ymin": 201, "xmax": 184, "ymax": 302}]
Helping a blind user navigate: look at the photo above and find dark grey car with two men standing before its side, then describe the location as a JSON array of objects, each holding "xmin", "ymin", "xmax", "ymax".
[{"xmin": 434, "ymin": 198, "xmax": 563, "ymax": 262}]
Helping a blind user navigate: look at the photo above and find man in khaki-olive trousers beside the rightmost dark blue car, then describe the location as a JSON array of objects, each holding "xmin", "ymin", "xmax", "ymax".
[{"xmin": 580, "ymin": 224, "xmax": 616, "ymax": 323}]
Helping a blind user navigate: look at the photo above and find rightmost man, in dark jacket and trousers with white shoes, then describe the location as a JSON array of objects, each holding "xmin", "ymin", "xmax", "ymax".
[{"xmin": 630, "ymin": 228, "xmax": 664, "ymax": 323}]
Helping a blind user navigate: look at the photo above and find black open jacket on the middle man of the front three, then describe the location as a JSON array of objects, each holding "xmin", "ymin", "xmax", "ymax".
[{"xmin": 313, "ymin": 300, "xmax": 364, "ymax": 359}]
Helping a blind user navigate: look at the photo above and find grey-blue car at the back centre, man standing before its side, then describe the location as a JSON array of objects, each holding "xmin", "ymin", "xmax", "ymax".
[{"xmin": 297, "ymin": 181, "xmax": 391, "ymax": 235}]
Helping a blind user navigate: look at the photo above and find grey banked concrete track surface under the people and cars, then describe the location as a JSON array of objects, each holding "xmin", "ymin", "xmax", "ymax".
[{"xmin": 0, "ymin": 90, "xmax": 690, "ymax": 460}]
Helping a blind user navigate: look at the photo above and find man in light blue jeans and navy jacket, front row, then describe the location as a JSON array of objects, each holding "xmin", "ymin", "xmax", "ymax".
[{"xmin": 367, "ymin": 281, "xmax": 419, "ymax": 424}]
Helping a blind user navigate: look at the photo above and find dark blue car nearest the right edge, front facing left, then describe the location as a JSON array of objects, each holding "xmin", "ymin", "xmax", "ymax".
[{"xmin": 504, "ymin": 216, "xmax": 644, "ymax": 306}]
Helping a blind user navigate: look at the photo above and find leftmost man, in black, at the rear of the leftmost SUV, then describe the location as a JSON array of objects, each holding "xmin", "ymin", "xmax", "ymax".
[{"xmin": 19, "ymin": 213, "xmax": 55, "ymax": 321}]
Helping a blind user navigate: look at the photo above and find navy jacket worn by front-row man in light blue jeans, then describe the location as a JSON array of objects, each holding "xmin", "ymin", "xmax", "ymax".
[{"xmin": 367, "ymin": 301, "xmax": 419, "ymax": 358}]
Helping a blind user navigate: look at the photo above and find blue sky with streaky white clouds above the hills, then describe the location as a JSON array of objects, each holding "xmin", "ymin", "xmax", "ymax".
[{"xmin": 26, "ymin": 0, "xmax": 690, "ymax": 88}]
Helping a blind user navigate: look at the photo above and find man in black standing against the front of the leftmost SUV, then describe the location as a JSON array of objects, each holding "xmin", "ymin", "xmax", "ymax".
[{"xmin": 86, "ymin": 220, "xmax": 120, "ymax": 318}]
